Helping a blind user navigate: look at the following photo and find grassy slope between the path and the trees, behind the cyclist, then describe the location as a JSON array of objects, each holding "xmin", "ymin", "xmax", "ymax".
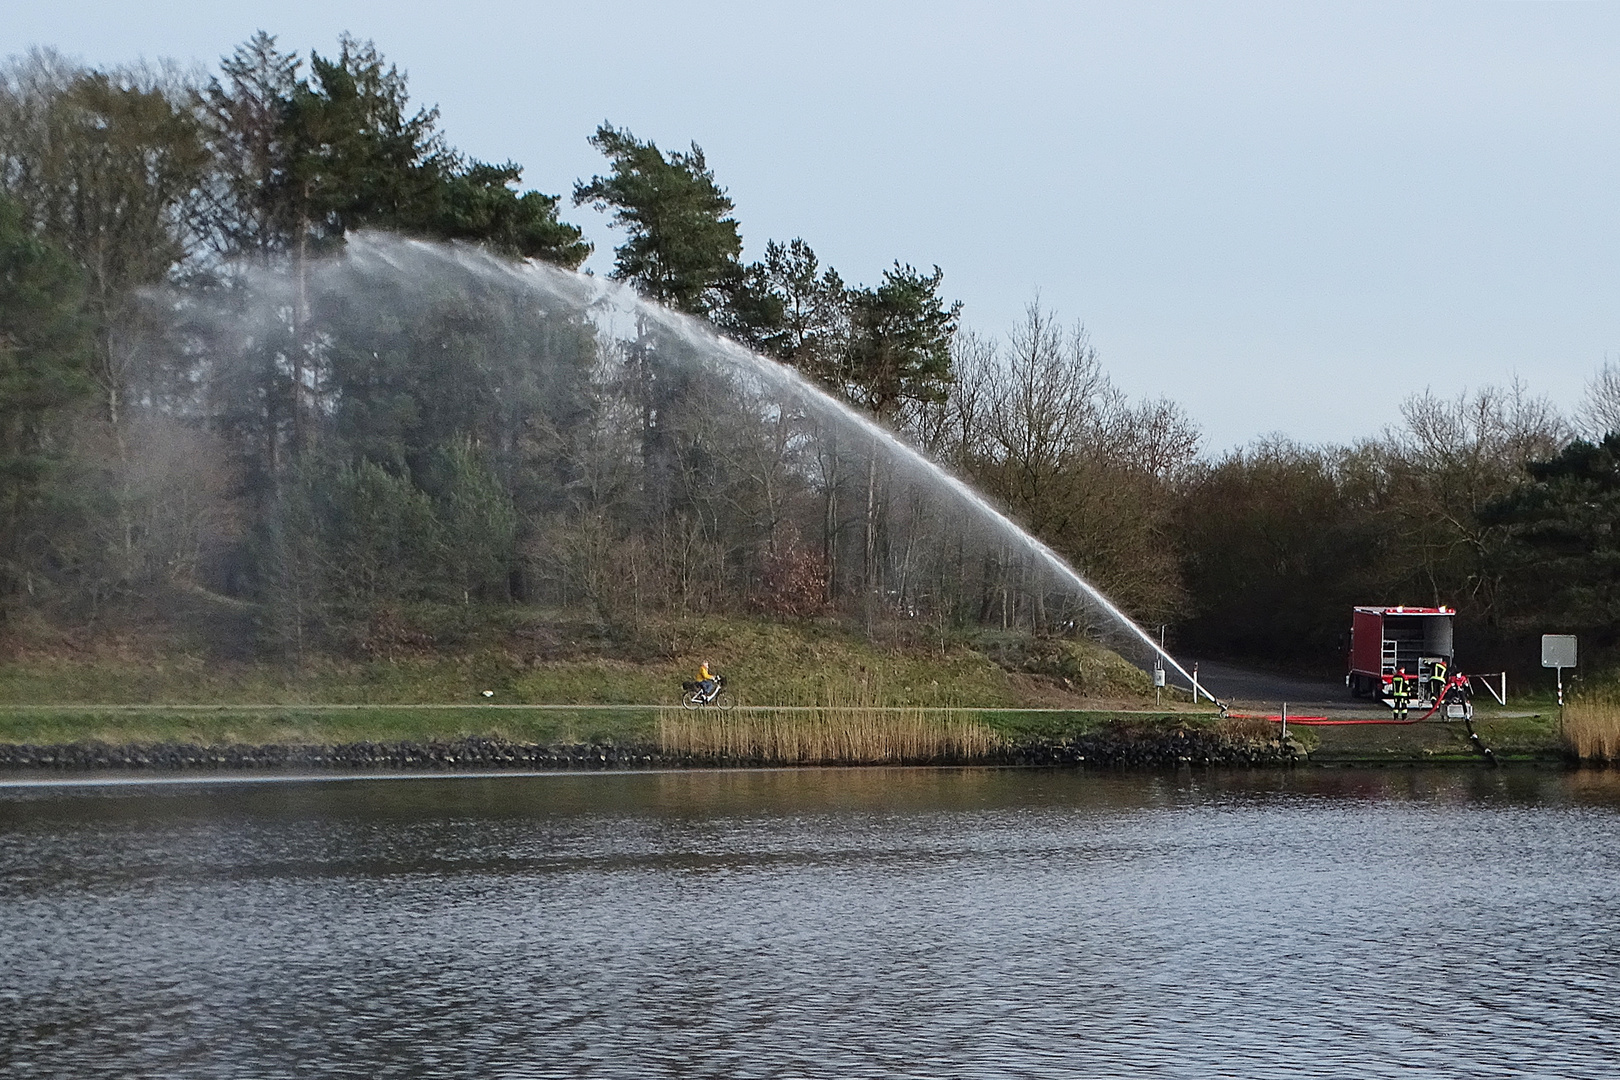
[{"xmin": 0, "ymin": 612, "xmax": 1152, "ymax": 709}]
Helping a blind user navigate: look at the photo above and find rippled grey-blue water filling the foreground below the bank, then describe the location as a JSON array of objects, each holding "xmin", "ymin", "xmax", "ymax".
[{"xmin": 0, "ymin": 769, "xmax": 1620, "ymax": 1078}]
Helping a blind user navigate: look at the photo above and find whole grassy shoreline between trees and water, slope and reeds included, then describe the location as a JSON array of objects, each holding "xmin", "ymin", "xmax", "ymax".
[{"xmin": 0, "ymin": 612, "xmax": 1581, "ymax": 764}]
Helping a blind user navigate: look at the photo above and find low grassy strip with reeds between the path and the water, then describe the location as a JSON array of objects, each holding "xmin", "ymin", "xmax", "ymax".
[{"xmin": 0, "ymin": 704, "xmax": 1568, "ymax": 766}]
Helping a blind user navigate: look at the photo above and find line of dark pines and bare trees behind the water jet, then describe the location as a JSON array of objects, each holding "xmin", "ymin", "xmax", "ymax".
[{"xmin": 0, "ymin": 32, "xmax": 1620, "ymax": 676}]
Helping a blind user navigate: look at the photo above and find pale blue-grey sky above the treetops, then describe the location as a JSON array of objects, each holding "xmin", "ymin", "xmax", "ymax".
[{"xmin": 0, "ymin": 0, "xmax": 1620, "ymax": 452}]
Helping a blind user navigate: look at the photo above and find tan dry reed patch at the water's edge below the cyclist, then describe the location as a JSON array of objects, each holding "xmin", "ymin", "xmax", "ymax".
[{"xmin": 658, "ymin": 706, "xmax": 1001, "ymax": 764}]
